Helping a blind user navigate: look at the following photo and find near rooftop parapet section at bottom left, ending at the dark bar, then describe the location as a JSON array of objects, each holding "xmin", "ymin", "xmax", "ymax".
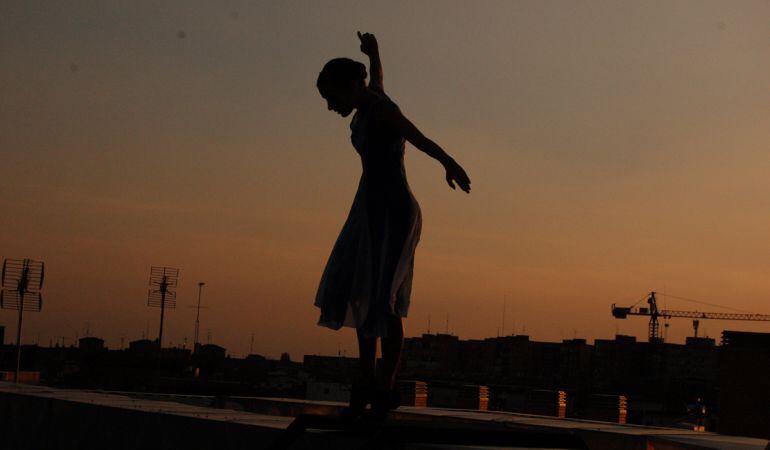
[{"xmin": 0, "ymin": 383, "xmax": 284, "ymax": 450}]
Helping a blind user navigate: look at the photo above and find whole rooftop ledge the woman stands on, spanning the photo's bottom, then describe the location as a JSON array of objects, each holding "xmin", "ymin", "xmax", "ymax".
[{"xmin": 0, "ymin": 382, "xmax": 768, "ymax": 450}]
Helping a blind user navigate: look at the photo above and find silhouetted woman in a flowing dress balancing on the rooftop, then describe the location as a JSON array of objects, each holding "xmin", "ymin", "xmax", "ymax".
[{"xmin": 315, "ymin": 33, "xmax": 470, "ymax": 418}]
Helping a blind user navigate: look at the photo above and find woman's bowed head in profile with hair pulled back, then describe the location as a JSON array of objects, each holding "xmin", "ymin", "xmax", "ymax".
[{"xmin": 316, "ymin": 58, "xmax": 366, "ymax": 117}]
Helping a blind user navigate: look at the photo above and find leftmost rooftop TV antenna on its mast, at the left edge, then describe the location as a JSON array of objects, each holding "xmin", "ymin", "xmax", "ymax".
[{"xmin": 0, "ymin": 258, "xmax": 45, "ymax": 383}]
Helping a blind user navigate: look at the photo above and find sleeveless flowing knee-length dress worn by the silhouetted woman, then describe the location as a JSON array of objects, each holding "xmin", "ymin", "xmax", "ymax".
[{"xmin": 315, "ymin": 94, "xmax": 422, "ymax": 337}]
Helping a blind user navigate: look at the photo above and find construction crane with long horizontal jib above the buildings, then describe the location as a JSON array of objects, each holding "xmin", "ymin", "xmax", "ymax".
[{"xmin": 612, "ymin": 291, "xmax": 770, "ymax": 342}]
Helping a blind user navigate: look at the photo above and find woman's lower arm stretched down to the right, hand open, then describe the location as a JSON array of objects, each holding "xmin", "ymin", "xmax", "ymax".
[{"xmin": 382, "ymin": 108, "xmax": 471, "ymax": 194}]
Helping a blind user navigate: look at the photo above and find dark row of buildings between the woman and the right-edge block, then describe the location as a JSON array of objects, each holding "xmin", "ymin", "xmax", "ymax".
[{"xmin": 401, "ymin": 334, "xmax": 717, "ymax": 425}]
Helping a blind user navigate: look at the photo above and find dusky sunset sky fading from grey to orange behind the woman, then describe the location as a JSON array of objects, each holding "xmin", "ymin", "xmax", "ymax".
[{"xmin": 0, "ymin": 0, "xmax": 770, "ymax": 359}]
